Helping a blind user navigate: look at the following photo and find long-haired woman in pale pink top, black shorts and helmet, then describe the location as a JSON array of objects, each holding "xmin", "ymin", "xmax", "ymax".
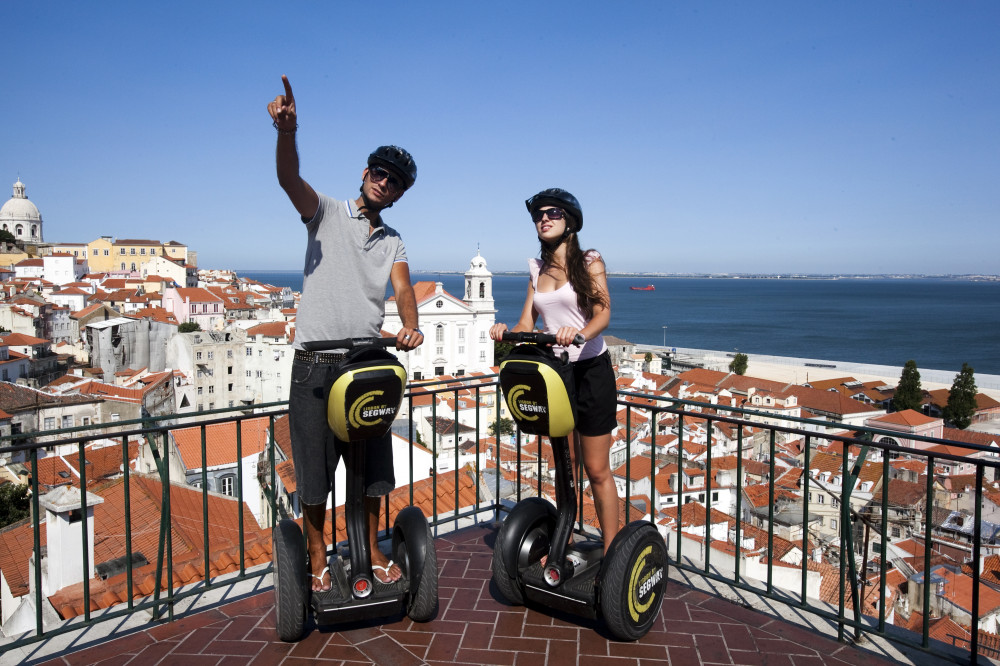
[{"xmin": 490, "ymin": 187, "xmax": 618, "ymax": 553}]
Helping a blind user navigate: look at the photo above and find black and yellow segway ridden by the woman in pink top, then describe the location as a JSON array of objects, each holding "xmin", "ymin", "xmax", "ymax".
[{"xmin": 493, "ymin": 333, "xmax": 667, "ymax": 641}]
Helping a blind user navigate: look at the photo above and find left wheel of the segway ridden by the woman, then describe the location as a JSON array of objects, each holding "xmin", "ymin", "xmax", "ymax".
[{"xmin": 492, "ymin": 497, "xmax": 557, "ymax": 605}]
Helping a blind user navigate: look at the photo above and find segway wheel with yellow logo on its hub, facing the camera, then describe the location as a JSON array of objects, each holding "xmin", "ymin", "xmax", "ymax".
[{"xmin": 599, "ymin": 521, "xmax": 667, "ymax": 641}]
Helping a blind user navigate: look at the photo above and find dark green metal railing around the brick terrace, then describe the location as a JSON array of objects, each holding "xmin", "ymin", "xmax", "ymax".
[{"xmin": 0, "ymin": 375, "xmax": 1000, "ymax": 663}]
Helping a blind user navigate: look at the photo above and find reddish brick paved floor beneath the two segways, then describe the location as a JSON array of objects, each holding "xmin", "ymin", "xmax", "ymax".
[{"xmin": 35, "ymin": 525, "xmax": 916, "ymax": 666}]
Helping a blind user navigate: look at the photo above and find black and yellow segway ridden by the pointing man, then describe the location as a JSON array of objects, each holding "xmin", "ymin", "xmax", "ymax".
[{"xmin": 271, "ymin": 338, "xmax": 438, "ymax": 641}]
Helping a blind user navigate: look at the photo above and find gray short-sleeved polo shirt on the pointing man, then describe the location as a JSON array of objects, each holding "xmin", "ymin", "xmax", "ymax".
[{"xmin": 294, "ymin": 194, "xmax": 406, "ymax": 349}]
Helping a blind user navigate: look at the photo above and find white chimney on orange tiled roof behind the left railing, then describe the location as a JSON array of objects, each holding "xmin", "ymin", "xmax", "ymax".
[{"xmin": 38, "ymin": 486, "xmax": 104, "ymax": 596}]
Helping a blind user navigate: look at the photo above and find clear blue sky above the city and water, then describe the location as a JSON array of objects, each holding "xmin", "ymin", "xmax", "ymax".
[{"xmin": 0, "ymin": 0, "xmax": 1000, "ymax": 273}]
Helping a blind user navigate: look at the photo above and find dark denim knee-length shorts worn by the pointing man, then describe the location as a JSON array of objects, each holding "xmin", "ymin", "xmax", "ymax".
[{"xmin": 288, "ymin": 360, "xmax": 396, "ymax": 505}]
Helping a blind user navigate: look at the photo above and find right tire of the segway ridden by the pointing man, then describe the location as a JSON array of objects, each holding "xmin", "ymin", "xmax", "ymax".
[{"xmin": 393, "ymin": 507, "xmax": 438, "ymax": 622}]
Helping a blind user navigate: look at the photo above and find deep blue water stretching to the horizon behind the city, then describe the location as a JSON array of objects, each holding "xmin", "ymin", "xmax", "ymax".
[{"xmin": 238, "ymin": 271, "xmax": 1000, "ymax": 375}]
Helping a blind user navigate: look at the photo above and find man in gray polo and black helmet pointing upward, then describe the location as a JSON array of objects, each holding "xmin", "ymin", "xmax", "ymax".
[{"xmin": 267, "ymin": 76, "xmax": 424, "ymax": 592}]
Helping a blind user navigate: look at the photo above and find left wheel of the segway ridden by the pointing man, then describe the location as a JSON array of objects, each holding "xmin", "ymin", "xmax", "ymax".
[{"xmin": 271, "ymin": 518, "xmax": 307, "ymax": 642}]
